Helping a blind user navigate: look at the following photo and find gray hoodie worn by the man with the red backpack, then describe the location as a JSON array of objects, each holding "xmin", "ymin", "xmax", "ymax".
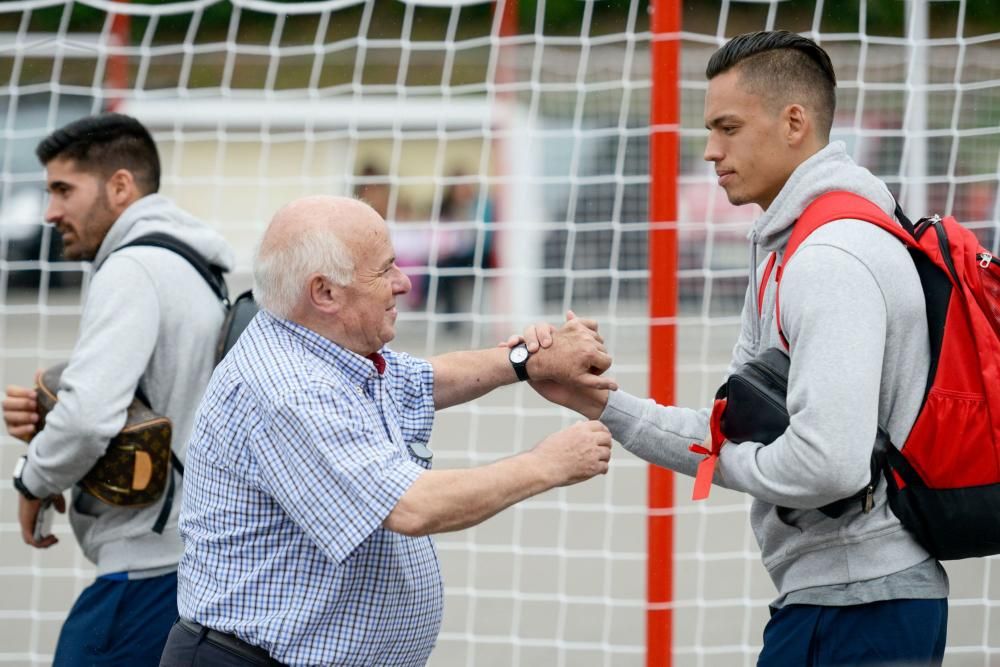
[{"xmin": 601, "ymin": 142, "xmax": 947, "ymax": 605}]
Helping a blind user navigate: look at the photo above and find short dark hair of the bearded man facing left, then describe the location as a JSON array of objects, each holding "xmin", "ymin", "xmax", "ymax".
[{"xmin": 35, "ymin": 113, "xmax": 160, "ymax": 195}]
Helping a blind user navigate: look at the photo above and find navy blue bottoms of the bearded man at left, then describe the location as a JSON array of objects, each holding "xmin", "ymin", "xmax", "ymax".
[{"xmin": 52, "ymin": 572, "xmax": 177, "ymax": 667}]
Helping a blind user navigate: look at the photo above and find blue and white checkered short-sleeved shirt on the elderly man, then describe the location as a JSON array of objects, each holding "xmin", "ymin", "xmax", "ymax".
[{"xmin": 178, "ymin": 312, "xmax": 443, "ymax": 667}]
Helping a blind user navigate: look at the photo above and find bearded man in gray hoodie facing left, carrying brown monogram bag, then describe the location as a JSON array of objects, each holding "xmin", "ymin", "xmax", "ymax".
[{"xmin": 3, "ymin": 114, "xmax": 233, "ymax": 666}]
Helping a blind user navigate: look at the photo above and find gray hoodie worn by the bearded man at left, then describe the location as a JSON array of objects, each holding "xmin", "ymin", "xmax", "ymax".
[{"xmin": 22, "ymin": 194, "xmax": 233, "ymax": 578}]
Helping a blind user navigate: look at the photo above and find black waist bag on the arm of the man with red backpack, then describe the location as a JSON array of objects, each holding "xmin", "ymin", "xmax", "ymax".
[{"xmin": 715, "ymin": 347, "xmax": 879, "ymax": 519}]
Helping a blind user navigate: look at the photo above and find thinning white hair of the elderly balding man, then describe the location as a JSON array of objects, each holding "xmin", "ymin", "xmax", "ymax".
[{"xmin": 253, "ymin": 217, "xmax": 354, "ymax": 319}]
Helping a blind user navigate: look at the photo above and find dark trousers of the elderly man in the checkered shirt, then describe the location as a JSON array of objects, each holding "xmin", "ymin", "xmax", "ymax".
[{"xmin": 160, "ymin": 619, "xmax": 281, "ymax": 667}]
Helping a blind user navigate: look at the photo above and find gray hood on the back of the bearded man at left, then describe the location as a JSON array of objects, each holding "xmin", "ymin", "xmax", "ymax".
[{"xmin": 94, "ymin": 194, "xmax": 235, "ymax": 271}]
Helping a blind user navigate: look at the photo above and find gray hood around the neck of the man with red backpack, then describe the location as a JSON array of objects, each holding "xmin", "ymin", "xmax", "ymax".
[{"xmin": 750, "ymin": 141, "xmax": 895, "ymax": 252}]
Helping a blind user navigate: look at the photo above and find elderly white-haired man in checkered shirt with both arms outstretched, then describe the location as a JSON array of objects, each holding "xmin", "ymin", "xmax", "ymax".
[{"xmin": 161, "ymin": 197, "xmax": 615, "ymax": 666}]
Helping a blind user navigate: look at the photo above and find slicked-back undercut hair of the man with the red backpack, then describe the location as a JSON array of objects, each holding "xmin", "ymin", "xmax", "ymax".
[{"xmin": 705, "ymin": 30, "xmax": 837, "ymax": 141}]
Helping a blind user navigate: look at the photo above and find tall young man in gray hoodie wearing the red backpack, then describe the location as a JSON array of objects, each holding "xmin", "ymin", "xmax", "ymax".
[{"xmin": 525, "ymin": 31, "xmax": 948, "ymax": 665}]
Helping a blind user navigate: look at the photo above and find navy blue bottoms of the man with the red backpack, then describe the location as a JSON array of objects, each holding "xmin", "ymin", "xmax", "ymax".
[{"xmin": 757, "ymin": 599, "xmax": 948, "ymax": 667}]
